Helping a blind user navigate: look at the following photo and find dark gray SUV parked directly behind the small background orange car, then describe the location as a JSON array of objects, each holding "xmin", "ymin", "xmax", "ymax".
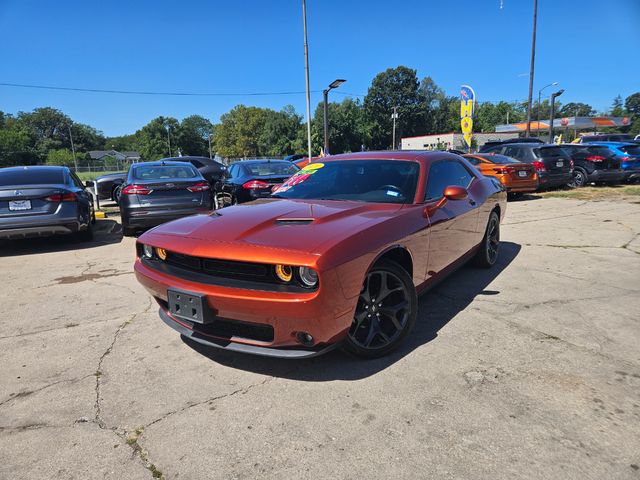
[{"xmin": 485, "ymin": 143, "xmax": 573, "ymax": 190}]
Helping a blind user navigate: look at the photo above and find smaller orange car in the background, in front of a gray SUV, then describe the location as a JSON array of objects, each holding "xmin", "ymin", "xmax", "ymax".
[{"xmin": 464, "ymin": 153, "xmax": 539, "ymax": 194}]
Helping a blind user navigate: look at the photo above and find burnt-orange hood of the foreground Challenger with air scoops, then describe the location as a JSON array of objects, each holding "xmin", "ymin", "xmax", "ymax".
[{"xmin": 140, "ymin": 199, "xmax": 402, "ymax": 254}]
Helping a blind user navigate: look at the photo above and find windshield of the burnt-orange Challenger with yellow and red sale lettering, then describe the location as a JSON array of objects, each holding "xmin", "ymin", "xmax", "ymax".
[{"xmin": 274, "ymin": 160, "xmax": 420, "ymax": 203}]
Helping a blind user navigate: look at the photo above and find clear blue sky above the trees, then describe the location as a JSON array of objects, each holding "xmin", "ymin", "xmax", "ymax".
[{"xmin": 0, "ymin": 0, "xmax": 640, "ymax": 135}]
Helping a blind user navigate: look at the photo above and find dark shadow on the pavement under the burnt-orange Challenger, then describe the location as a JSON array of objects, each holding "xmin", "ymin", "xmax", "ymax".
[{"xmin": 182, "ymin": 242, "xmax": 521, "ymax": 382}]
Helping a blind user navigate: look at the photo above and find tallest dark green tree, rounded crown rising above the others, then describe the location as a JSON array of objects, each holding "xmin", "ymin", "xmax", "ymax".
[{"xmin": 364, "ymin": 66, "xmax": 426, "ymax": 149}]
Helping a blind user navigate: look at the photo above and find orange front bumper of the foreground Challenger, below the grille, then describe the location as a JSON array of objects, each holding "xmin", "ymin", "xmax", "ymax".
[{"xmin": 135, "ymin": 259, "xmax": 355, "ymax": 358}]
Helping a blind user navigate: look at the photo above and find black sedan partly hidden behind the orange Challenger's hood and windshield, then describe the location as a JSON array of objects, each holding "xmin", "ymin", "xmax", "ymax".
[{"xmin": 222, "ymin": 160, "xmax": 300, "ymax": 205}]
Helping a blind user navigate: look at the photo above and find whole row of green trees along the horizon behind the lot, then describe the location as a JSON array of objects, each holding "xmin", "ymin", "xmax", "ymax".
[{"xmin": 0, "ymin": 66, "xmax": 640, "ymax": 166}]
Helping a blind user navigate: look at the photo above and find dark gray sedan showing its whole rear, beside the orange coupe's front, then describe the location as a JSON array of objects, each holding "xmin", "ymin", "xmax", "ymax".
[{"xmin": 119, "ymin": 160, "xmax": 211, "ymax": 235}]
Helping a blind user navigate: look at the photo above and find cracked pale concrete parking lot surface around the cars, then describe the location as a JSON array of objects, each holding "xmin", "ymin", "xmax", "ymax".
[{"xmin": 0, "ymin": 198, "xmax": 640, "ymax": 479}]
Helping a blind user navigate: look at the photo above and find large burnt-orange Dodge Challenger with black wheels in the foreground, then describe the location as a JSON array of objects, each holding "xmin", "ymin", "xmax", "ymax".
[{"xmin": 135, "ymin": 152, "xmax": 506, "ymax": 358}]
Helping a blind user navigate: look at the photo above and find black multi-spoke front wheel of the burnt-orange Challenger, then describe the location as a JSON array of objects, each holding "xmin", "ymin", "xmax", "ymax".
[{"xmin": 345, "ymin": 260, "xmax": 418, "ymax": 358}]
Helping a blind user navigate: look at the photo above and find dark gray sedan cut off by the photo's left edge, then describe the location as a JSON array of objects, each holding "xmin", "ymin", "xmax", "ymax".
[{"xmin": 0, "ymin": 166, "xmax": 95, "ymax": 240}]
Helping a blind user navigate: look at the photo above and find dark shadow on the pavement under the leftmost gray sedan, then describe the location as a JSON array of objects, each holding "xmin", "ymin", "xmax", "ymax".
[{"xmin": 0, "ymin": 219, "xmax": 122, "ymax": 257}]
